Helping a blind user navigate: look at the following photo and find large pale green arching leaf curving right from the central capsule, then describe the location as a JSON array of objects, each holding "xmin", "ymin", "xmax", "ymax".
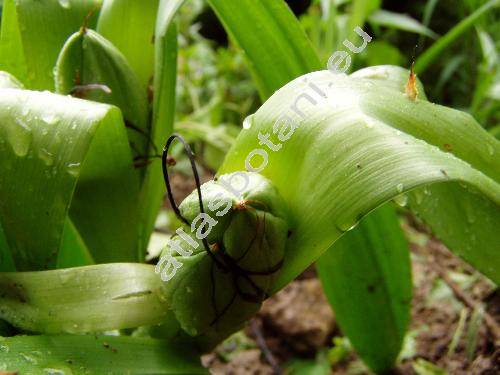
[{"xmin": 219, "ymin": 67, "xmax": 500, "ymax": 289}]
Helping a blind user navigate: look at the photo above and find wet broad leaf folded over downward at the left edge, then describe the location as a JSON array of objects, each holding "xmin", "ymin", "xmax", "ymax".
[{"xmin": 0, "ymin": 89, "xmax": 138, "ymax": 270}]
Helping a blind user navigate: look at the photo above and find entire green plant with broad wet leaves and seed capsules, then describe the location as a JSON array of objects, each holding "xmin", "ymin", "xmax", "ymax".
[{"xmin": 0, "ymin": 0, "xmax": 500, "ymax": 374}]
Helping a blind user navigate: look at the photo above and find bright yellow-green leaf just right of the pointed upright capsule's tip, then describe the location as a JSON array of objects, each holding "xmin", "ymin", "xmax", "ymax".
[{"xmin": 97, "ymin": 0, "xmax": 159, "ymax": 90}]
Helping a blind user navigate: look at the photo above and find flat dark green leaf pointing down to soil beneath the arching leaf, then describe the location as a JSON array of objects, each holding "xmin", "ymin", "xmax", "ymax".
[{"xmin": 317, "ymin": 204, "xmax": 412, "ymax": 372}]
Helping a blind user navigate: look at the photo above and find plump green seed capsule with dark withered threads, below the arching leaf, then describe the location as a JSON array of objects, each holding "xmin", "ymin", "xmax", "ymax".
[{"xmin": 158, "ymin": 172, "xmax": 288, "ymax": 345}]
